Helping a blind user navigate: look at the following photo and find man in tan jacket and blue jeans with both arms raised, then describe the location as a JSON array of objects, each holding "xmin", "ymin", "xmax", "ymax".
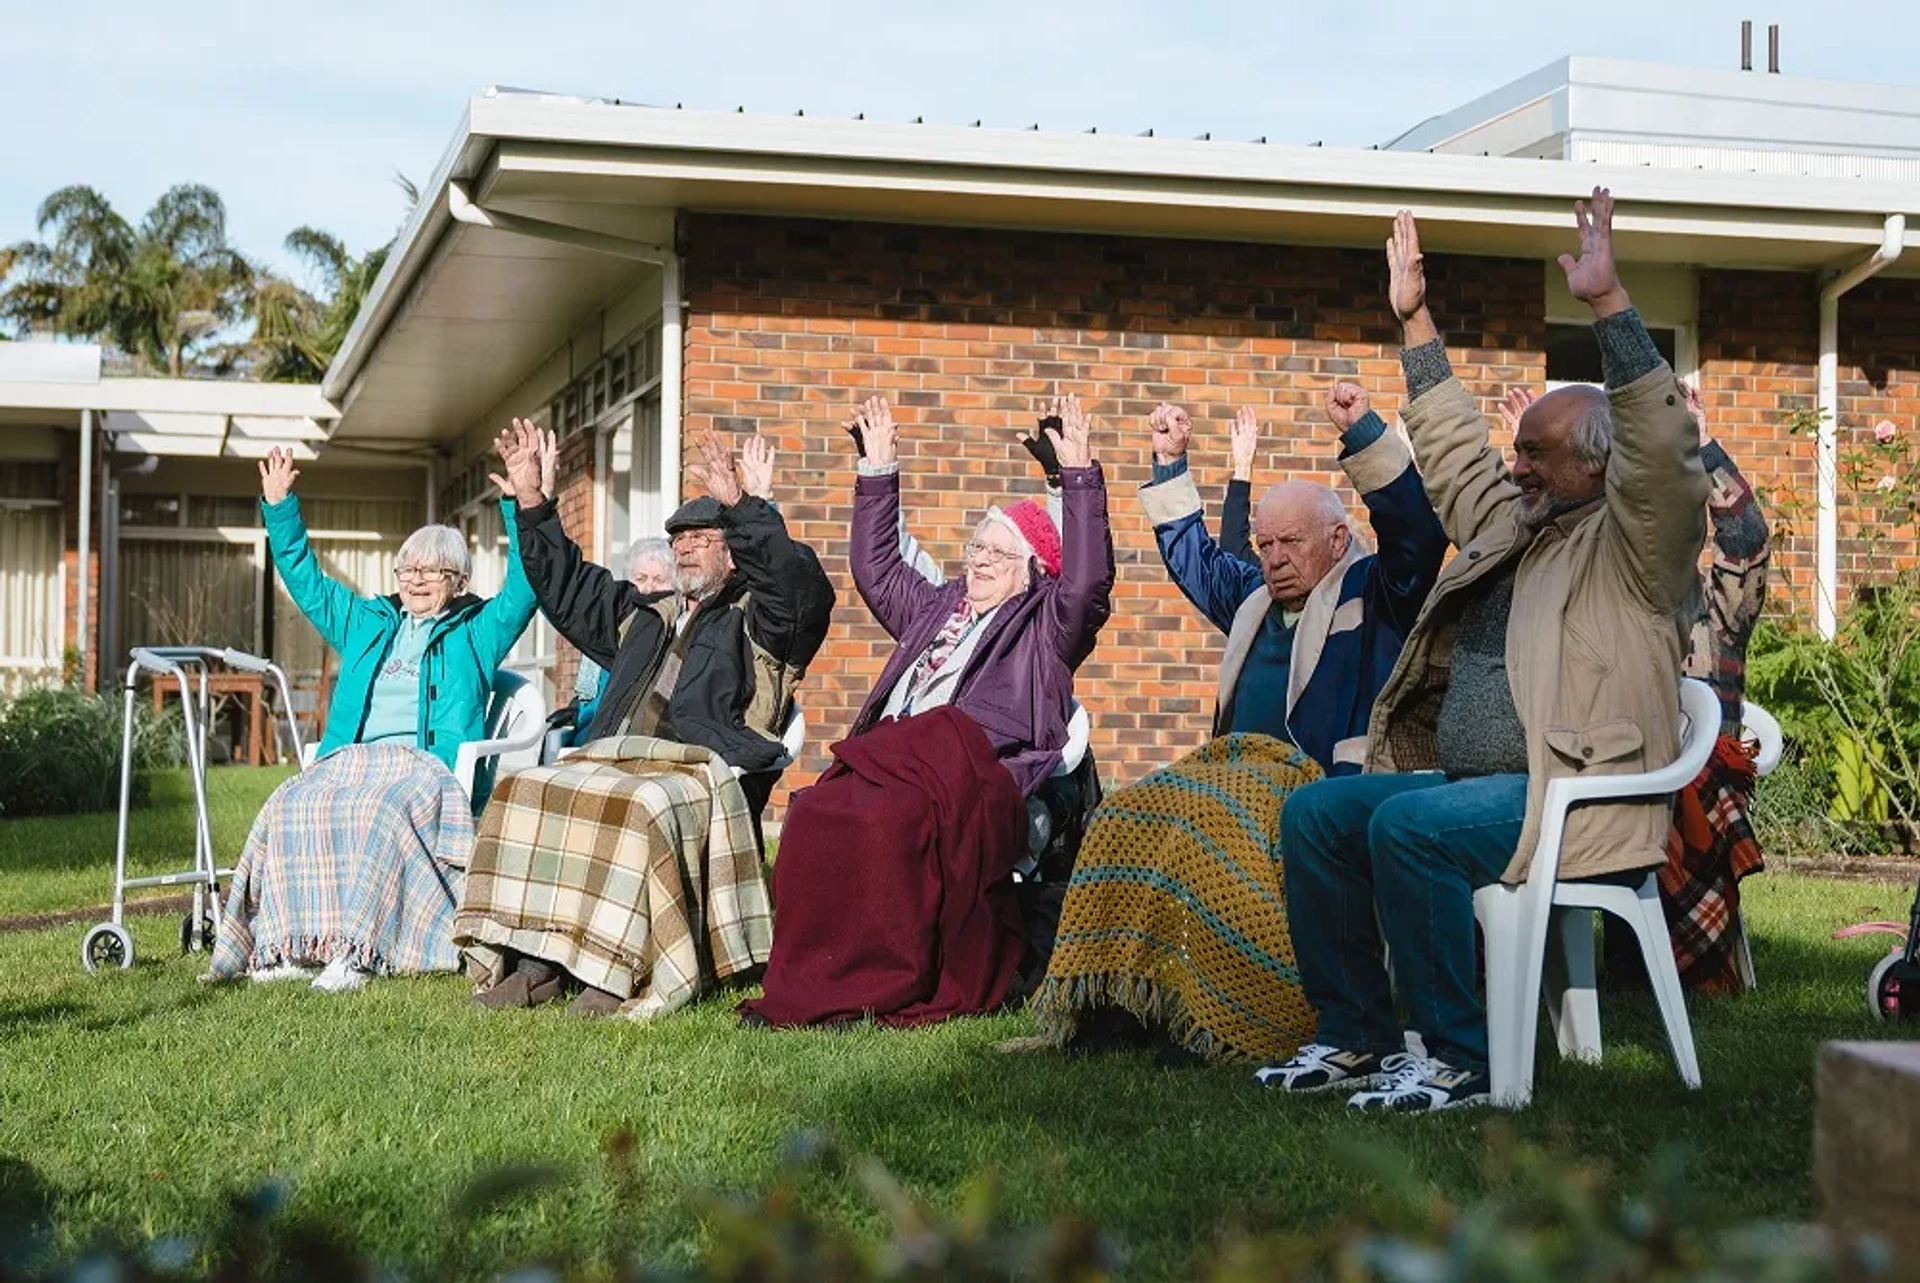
[{"xmin": 1258, "ymin": 188, "xmax": 1707, "ymax": 1110}]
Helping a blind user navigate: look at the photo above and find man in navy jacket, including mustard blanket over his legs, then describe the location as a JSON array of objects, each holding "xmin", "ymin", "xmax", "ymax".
[{"xmin": 1033, "ymin": 384, "xmax": 1446, "ymax": 1064}]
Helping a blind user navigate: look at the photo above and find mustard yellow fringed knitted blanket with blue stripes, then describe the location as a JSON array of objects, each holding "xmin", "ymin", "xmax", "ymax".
[{"xmin": 1033, "ymin": 734, "xmax": 1321, "ymax": 1060}]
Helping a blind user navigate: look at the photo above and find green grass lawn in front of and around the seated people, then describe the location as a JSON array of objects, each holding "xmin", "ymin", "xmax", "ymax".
[{"xmin": 0, "ymin": 772, "xmax": 1910, "ymax": 1277}]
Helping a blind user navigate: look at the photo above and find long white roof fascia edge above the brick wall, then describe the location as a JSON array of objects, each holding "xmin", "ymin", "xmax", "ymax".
[{"xmin": 321, "ymin": 94, "xmax": 1920, "ymax": 407}]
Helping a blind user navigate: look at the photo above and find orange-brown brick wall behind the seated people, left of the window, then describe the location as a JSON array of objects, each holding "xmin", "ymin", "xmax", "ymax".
[{"xmin": 685, "ymin": 215, "xmax": 1546, "ymax": 802}]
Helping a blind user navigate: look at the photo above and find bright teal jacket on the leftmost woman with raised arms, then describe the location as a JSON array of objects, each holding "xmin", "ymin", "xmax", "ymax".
[{"xmin": 261, "ymin": 496, "xmax": 536, "ymax": 770}]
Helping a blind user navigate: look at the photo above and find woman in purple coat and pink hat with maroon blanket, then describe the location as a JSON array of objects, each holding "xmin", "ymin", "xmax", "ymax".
[{"xmin": 743, "ymin": 398, "xmax": 1114, "ymax": 1026}]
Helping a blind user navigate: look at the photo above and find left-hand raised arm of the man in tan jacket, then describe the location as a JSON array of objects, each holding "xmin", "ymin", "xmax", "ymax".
[{"xmin": 1386, "ymin": 209, "xmax": 1521, "ymax": 547}]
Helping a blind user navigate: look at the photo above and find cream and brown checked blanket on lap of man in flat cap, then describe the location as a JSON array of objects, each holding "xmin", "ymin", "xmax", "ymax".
[{"xmin": 453, "ymin": 736, "xmax": 774, "ymax": 1018}]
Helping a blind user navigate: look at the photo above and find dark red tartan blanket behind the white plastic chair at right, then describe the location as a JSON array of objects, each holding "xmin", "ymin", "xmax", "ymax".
[{"xmin": 1659, "ymin": 736, "xmax": 1764, "ymax": 993}]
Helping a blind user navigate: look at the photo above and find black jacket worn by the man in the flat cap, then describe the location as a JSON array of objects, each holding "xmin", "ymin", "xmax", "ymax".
[{"xmin": 518, "ymin": 496, "xmax": 833, "ymax": 772}]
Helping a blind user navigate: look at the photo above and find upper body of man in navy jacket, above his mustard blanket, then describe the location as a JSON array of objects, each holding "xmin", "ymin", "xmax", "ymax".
[{"xmin": 1140, "ymin": 391, "xmax": 1446, "ymax": 774}]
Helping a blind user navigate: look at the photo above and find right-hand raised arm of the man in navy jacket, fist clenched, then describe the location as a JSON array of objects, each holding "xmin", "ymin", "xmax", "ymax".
[{"xmin": 1327, "ymin": 382, "xmax": 1446, "ymax": 630}]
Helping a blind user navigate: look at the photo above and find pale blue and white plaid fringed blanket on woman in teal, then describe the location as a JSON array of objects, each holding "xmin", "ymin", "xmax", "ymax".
[{"xmin": 211, "ymin": 743, "xmax": 474, "ymax": 980}]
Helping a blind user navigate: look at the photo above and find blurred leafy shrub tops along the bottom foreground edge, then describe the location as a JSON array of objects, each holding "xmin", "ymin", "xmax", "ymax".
[{"xmin": 0, "ymin": 1124, "xmax": 1891, "ymax": 1283}]
